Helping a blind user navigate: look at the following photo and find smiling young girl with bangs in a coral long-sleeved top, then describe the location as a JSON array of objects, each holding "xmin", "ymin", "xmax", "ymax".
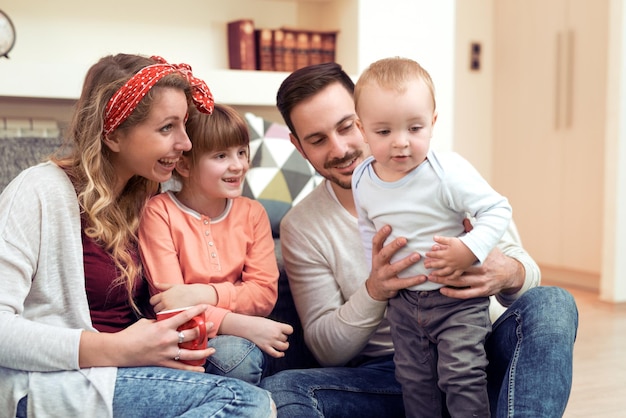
[{"xmin": 139, "ymin": 105, "xmax": 293, "ymax": 384}]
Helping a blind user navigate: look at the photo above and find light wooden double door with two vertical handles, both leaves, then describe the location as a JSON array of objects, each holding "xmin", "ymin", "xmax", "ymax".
[{"xmin": 493, "ymin": 0, "xmax": 608, "ymax": 288}]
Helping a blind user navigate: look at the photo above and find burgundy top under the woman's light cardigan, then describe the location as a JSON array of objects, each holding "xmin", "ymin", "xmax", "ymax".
[{"xmin": 81, "ymin": 225, "xmax": 149, "ymax": 332}]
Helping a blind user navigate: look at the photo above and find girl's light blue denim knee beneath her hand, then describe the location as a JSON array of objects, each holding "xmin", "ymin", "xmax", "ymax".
[{"xmin": 205, "ymin": 335, "xmax": 265, "ymax": 385}]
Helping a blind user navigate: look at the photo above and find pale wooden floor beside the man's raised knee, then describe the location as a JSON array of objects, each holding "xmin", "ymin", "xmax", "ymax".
[{"xmin": 544, "ymin": 283, "xmax": 626, "ymax": 418}]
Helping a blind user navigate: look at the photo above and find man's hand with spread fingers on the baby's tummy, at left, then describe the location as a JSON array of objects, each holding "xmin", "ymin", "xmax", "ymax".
[{"xmin": 365, "ymin": 225, "xmax": 426, "ymax": 301}]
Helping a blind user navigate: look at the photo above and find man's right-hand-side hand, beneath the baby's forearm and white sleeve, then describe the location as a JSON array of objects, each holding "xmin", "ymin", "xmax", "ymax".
[{"xmin": 426, "ymin": 248, "xmax": 525, "ymax": 299}]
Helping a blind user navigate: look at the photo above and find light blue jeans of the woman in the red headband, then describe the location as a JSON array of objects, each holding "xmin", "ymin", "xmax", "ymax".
[{"xmin": 17, "ymin": 367, "xmax": 273, "ymax": 418}]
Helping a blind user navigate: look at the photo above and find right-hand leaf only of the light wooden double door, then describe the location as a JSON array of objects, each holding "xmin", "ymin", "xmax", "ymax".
[{"xmin": 561, "ymin": 0, "xmax": 608, "ymax": 274}]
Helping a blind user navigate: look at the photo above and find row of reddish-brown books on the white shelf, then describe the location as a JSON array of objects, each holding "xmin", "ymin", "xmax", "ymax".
[{"xmin": 228, "ymin": 19, "xmax": 337, "ymax": 72}]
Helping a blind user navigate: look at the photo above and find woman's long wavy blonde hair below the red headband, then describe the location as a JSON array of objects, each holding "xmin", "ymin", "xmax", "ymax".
[{"xmin": 52, "ymin": 54, "xmax": 191, "ymax": 312}]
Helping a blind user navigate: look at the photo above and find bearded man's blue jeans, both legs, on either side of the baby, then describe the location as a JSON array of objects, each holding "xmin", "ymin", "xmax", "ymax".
[{"xmin": 261, "ymin": 287, "xmax": 578, "ymax": 418}]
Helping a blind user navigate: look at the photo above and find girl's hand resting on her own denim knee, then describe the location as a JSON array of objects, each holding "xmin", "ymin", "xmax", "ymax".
[{"xmin": 243, "ymin": 316, "xmax": 293, "ymax": 358}]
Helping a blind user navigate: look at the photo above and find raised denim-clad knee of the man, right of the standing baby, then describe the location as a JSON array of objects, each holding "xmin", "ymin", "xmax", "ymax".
[{"xmin": 485, "ymin": 287, "xmax": 578, "ymax": 418}]
